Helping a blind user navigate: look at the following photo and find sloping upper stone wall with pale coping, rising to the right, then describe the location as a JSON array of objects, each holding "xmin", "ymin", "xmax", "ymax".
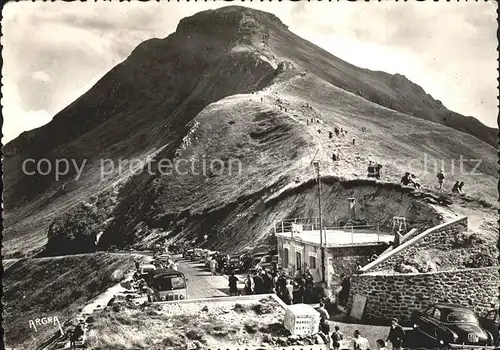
[{"xmin": 363, "ymin": 217, "xmax": 467, "ymax": 272}]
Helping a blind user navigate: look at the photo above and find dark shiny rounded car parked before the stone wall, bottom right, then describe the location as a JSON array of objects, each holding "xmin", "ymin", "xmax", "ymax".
[{"xmin": 412, "ymin": 303, "xmax": 494, "ymax": 349}]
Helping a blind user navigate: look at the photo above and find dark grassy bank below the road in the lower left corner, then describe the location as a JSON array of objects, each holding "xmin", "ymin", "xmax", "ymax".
[{"xmin": 3, "ymin": 253, "xmax": 141, "ymax": 349}]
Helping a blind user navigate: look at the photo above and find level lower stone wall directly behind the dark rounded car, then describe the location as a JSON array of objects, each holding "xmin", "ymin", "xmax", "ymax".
[{"xmin": 349, "ymin": 266, "xmax": 500, "ymax": 324}]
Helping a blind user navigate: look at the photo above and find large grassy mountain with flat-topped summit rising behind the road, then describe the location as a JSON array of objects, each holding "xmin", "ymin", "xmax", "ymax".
[{"xmin": 4, "ymin": 6, "xmax": 496, "ymax": 255}]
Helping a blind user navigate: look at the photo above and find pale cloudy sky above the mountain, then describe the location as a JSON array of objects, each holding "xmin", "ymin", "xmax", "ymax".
[{"xmin": 1, "ymin": 0, "xmax": 498, "ymax": 144}]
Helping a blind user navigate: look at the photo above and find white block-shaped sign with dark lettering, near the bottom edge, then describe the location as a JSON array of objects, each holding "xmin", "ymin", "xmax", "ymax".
[{"xmin": 283, "ymin": 304, "xmax": 320, "ymax": 336}]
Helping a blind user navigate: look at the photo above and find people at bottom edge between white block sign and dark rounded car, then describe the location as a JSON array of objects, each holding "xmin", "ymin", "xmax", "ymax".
[{"xmin": 318, "ymin": 318, "xmax": 405, "ymax": 350}]
